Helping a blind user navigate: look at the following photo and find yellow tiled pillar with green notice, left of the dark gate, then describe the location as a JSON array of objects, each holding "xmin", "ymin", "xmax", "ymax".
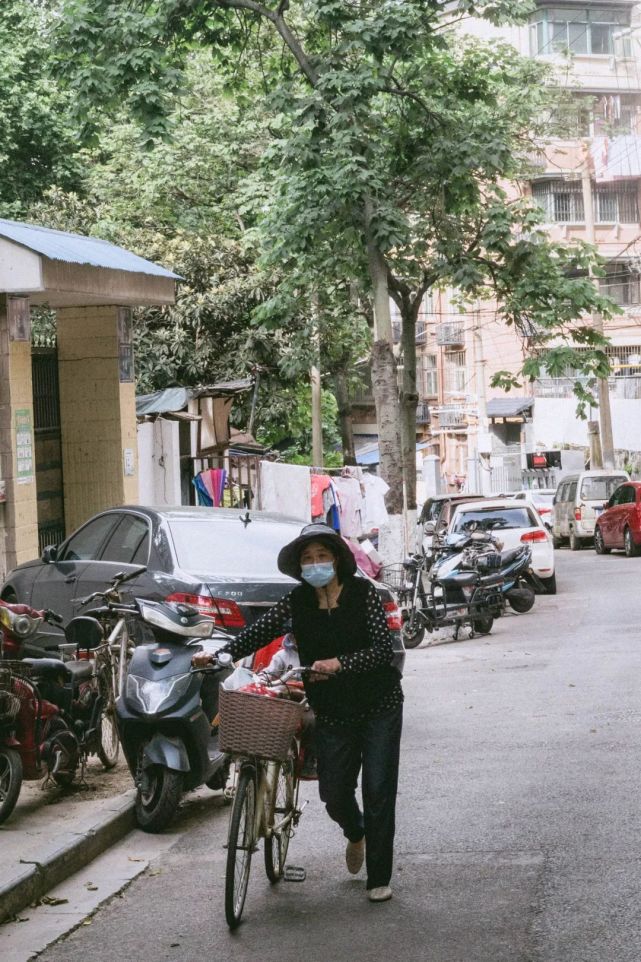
[{"xmin": 0, "ymin": 294, "xmax": 38, "ymax": 578}]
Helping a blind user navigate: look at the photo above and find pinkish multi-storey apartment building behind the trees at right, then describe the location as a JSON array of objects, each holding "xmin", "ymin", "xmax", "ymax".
[{"xmin": 418, "ymin": 2, "xmax": 641, "ymax": 492}]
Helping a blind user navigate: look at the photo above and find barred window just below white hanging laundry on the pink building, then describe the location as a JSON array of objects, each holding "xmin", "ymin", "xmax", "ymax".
[{"xmin": 532, "ymin": 180, "xmax": 639, "ymax": 224}]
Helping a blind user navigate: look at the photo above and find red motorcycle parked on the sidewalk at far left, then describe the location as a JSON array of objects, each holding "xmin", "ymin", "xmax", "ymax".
[{"xmin": 0, "ymin": 602, "xmax": 113, "ymax": 822}]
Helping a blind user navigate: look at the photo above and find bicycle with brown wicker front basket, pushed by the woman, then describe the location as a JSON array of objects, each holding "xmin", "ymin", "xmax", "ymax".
[{"xmin": 219, "ymin": 667, "xmax": 320, "ymax": 930}]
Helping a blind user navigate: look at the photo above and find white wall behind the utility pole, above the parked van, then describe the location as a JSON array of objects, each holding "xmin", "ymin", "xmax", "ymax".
[{"xmin": 534, "ymin": 398, "xmax": 641, "ymax": 451}]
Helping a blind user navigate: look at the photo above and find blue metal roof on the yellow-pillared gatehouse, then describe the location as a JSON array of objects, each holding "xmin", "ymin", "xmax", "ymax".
[{"xmin": 0, "ymin": 219, "xmax": 181, "ymax": 280}]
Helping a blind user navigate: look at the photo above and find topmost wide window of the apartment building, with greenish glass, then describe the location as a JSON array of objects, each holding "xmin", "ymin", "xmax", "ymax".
[{"xmin": 530, "ymin": 7, "xmax": 631, "ymax": 57}]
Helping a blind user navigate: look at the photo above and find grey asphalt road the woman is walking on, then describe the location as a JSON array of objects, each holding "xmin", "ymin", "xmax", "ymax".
[{"xmin": 33, "ymin": 550, "xmax": 641, "ymax": 962}]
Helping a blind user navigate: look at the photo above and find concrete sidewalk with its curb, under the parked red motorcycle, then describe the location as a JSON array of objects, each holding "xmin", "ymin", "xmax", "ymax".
[{"xmin": 0, "ymin": 769, "xmax": 134, "ymax": 922}]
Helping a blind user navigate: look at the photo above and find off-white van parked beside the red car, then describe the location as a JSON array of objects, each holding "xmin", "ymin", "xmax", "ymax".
[{"xmin": 552, "ymin": 468, "xmax": 630, "ymax": 551}]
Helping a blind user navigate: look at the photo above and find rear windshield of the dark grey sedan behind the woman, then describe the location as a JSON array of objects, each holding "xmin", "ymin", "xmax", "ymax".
[{"xmin": 170, "ymin": 518, "xmax": 300, "ymax": 579}]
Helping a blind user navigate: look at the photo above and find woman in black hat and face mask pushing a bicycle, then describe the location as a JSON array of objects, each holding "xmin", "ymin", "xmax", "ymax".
[{"xmin": 194, "ymin": 524, "xmax": 403, "ymax": 902}]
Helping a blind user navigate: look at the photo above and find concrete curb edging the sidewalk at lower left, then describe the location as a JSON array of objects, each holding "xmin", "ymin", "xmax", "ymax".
[{"xmin": 0, "ymin": 792, "xmax": 135, "ymax": 923}]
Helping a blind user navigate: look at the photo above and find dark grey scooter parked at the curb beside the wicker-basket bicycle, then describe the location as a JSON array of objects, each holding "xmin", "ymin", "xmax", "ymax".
[{"xmin": 116, "ymin": 600, "xmax": 232, "ymax": 832}]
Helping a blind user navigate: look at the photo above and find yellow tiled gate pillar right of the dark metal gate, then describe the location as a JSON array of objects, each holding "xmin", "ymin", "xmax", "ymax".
[{"xmin": 57, "ymin": 307, "xmax": 138, "ymax": 533}]
